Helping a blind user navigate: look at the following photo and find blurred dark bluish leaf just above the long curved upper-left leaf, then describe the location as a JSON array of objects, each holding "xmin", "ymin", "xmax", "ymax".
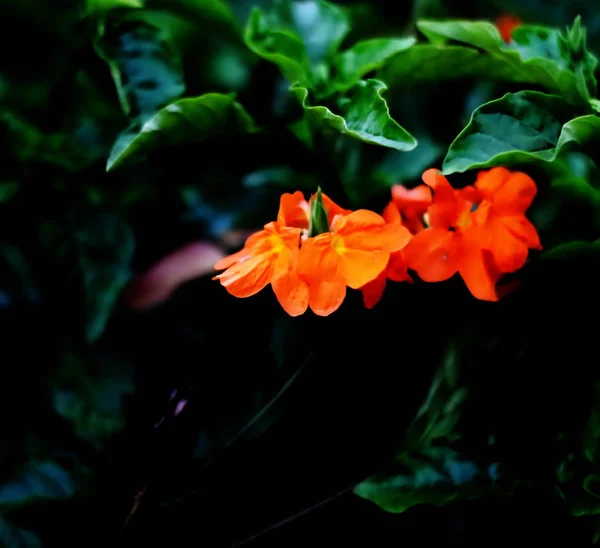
[{"xmin": 96, "ymin": 20, "xmax": 185, "ymax": 120}]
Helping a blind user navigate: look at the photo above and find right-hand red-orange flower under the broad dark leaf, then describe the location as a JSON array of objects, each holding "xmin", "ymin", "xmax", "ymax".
[{"xmin": 405, "ymin": 168, "xmax": 539, "ymax": 301}]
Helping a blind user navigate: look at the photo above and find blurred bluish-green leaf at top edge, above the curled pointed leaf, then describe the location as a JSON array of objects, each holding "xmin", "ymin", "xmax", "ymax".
[{"xmin": 244, "ymin": 0, "xmax": 349, "ymax": 88}]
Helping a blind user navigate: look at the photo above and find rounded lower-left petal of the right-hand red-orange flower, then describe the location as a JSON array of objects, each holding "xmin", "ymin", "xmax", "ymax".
[{"xmin": 404, "ymin": 228, "xmax": 461, "ymax": 282}]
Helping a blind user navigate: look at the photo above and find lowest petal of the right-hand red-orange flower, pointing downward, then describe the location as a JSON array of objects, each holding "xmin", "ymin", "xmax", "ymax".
[{"xmin": 458, "ymin": 242, "xmax": 500, "ymax": 301}]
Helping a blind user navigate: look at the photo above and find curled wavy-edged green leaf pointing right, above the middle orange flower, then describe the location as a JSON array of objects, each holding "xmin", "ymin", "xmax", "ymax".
[{"xmin": 291, "ymin": 80, "xmax": 417, "ymax": 151}]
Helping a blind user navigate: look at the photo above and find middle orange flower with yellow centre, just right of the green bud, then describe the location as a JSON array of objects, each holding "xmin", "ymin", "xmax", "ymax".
[{"xmin": 298, "ymin": 209, "xmax": 411, "ymax": 316}]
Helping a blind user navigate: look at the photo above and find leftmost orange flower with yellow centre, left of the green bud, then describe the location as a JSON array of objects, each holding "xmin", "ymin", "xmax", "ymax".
[{"xmin": 213, "ymin": 223, "xmax": 309, "ymax": 316}]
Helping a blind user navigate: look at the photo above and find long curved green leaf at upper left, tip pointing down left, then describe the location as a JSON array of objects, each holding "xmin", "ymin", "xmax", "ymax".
[{"xmin": 106, "ymin": 93, "xmax": 256, "ymax": 171}]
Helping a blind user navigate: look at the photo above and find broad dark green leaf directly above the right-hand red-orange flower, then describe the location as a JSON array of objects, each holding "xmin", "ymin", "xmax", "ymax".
[{"xmin": 443, "ymin": 91, "xmax": 600, "ymax": 174}]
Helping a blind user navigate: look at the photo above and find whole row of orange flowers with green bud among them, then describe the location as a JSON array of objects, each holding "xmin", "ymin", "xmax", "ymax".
[{"xmin": 214, "ymin": 167, "xmax": 541, "ymax": 316}]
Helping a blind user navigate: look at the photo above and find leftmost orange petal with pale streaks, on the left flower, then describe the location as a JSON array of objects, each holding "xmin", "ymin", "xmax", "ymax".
[{"xmin": 213, "ymin": 252, "xmax": 276, "ymax": 298}]
